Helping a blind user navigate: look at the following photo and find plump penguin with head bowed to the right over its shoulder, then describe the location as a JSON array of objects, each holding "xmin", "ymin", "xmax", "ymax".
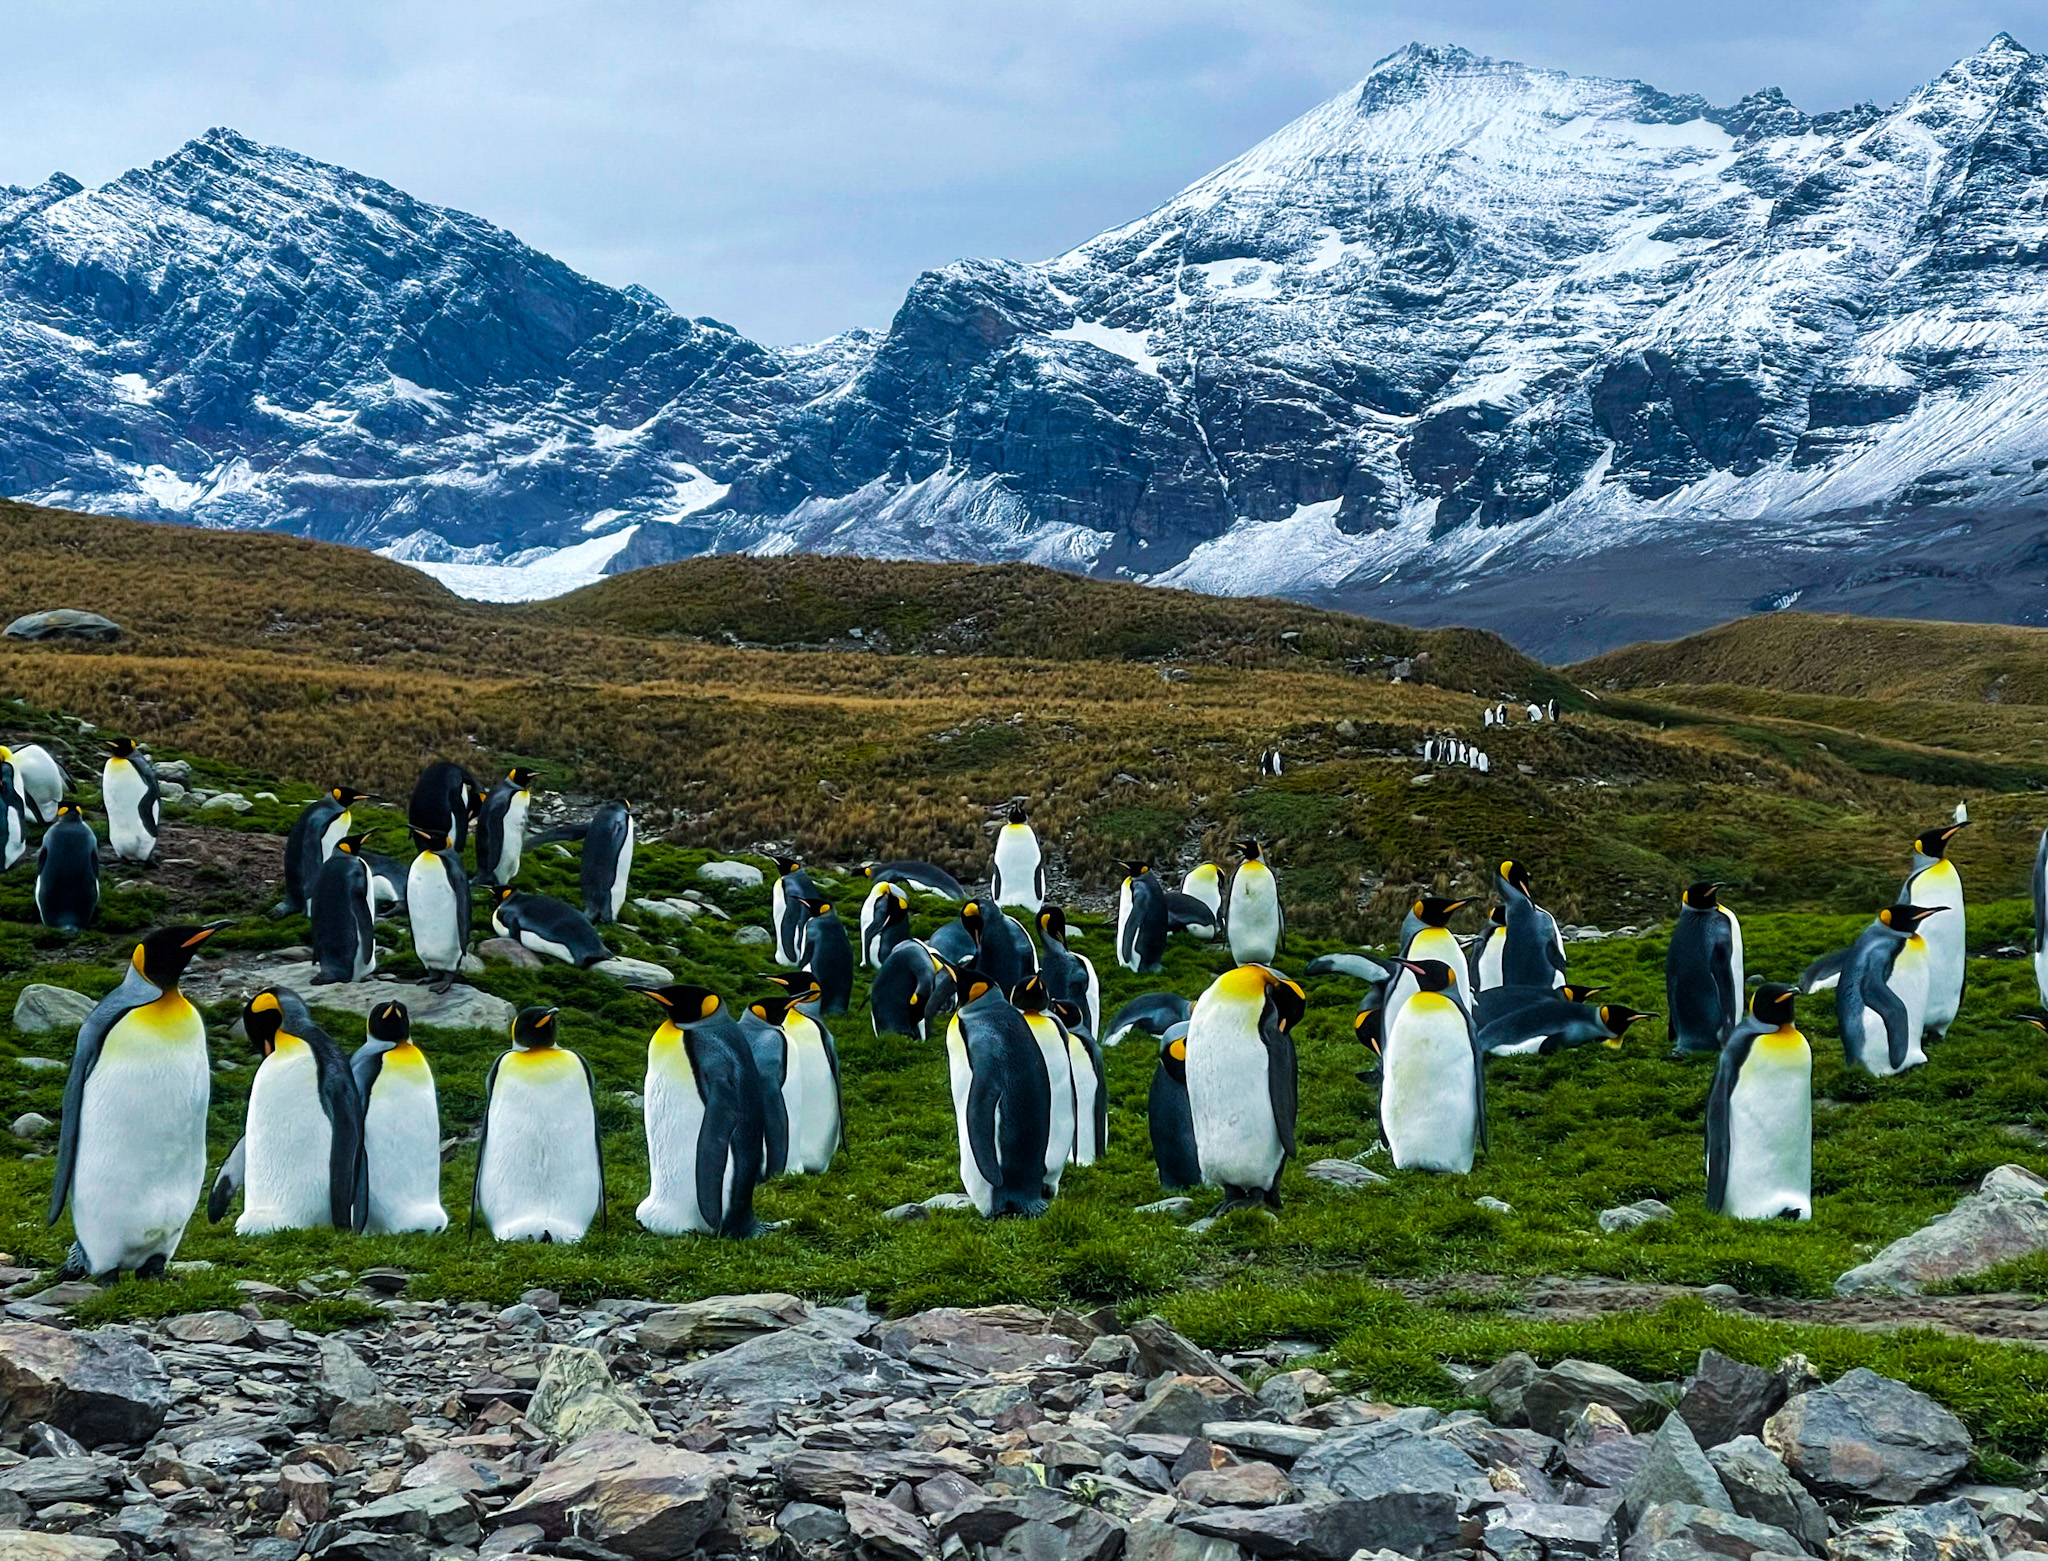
[{"xmin": 1188, "ymin": 965, "xmax": 1307, "ymax": 1213}]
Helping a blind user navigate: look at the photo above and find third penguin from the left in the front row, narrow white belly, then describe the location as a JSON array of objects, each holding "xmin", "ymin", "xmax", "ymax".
[{"xmin": 348, "ymin": 1003, "xmax": 455, "ymax": 1235}]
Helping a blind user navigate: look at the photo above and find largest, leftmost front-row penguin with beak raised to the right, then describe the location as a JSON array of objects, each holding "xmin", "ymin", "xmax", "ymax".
[{"xmin": 47, "ymin": 926, "xmax": 217, "ymax": 1278}]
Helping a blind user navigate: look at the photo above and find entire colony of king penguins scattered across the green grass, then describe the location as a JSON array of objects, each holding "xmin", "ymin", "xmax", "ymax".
[{"xmin": 0, "ymin": 725, "xmax": 2048, "ymax": 1276}]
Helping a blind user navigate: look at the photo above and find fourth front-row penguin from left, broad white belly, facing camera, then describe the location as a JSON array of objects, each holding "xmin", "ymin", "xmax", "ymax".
[{"xmin": 469, "ymin": 1008, "xmax": 604, "ymax": 1241}]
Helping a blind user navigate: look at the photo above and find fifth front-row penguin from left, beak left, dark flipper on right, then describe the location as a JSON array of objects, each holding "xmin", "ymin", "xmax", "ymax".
[{"xmin": 637, "ymin": 985, "xmax": 766, "ymax": 1237}]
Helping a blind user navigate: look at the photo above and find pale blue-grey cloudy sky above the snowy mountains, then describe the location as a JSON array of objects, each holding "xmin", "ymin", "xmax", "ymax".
[{"xmin": 0, "ymin": 0, "xmax": 2015, "ymax": 342}]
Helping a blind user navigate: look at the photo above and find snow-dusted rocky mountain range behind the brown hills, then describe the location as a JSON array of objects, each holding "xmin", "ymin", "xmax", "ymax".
[{"xmin": 0, "ymin": 35, "xmax": 2048, "ymax": 656}]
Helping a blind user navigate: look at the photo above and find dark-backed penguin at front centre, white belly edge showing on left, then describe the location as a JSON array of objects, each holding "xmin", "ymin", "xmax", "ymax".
[{"xmin": 946, "ymin": 967, "xmax": 1053, "ymax": 1219}]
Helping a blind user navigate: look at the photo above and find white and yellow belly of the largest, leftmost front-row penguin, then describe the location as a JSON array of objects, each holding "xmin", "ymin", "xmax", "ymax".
[{"xmin": 72, "ymin": 996, "xmax": 213, "ymax": 1274}]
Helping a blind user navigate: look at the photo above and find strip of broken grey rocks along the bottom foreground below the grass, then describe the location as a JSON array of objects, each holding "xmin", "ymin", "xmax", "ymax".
[{"xmin": 0, "ymin": 1270, "xmax": 2048, "ymax": 1561}]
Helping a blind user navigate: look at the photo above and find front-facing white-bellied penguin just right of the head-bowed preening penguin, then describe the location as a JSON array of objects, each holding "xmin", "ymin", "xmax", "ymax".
[{"xmin": 1380, "ymin": 959, "xmax": 1487, "ymax": 1176}]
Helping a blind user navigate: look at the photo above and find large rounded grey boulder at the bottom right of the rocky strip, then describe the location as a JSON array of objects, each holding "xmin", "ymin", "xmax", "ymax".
[{"xmin": 1763, "ymin": 1366, "xmax": 1970, "ymax": 1502}]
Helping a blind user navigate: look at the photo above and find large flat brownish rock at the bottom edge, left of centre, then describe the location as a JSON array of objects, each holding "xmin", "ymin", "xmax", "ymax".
[{"xmin": 492, "ymin": 1430, "xmax": 731, "ymax": 1561}]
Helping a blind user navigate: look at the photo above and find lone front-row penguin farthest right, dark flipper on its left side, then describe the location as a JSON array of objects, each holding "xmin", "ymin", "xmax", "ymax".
[{"xmin": 1706, "ymin": 985, "xmax": 1812, "ymax": 1219}]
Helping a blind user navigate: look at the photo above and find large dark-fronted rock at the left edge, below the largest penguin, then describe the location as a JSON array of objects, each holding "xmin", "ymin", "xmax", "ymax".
[{"xmin": 0, "ymin": 1323, "xmax": 170, "ymax": 1446}]
